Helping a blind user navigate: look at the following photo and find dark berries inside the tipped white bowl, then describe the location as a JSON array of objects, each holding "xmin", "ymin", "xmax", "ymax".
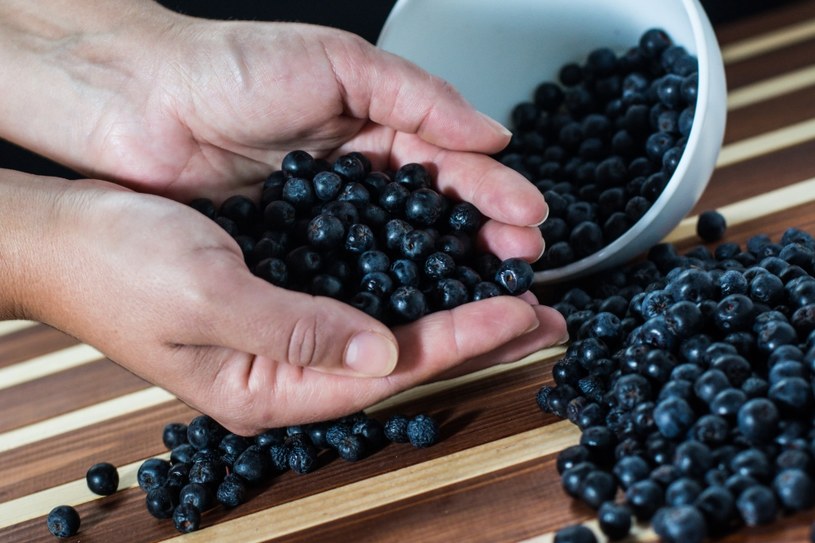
[{"xmin": 498, "ymin": 29, "xmax": 698, "ymax": 270}]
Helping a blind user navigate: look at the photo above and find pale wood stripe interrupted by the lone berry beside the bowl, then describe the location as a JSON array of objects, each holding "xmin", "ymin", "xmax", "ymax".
[{"xmin": 663, "ymin": 177, "xmax": 815, "ymax": 243}]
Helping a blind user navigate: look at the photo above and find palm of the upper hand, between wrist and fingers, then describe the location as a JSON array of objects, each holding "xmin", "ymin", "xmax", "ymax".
[{"xmin": 91, "ymin": 22, "xmax": 384, "ymax": 200}]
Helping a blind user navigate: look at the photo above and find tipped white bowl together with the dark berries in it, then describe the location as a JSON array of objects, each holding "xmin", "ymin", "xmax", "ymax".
[{"xmin": 379, "ymin": 0, "xmax": 726, "ymax": 283}]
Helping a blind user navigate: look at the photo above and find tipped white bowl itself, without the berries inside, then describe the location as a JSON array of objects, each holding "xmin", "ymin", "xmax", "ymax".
[{"xmin": 378, "ymin": 0, "xmax": 727, "ymax": 283}]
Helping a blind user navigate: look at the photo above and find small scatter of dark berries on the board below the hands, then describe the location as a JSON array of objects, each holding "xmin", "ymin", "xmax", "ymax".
[{"xmin": 46, "ymin": 412, "xmax": 439, "ymax": 537}]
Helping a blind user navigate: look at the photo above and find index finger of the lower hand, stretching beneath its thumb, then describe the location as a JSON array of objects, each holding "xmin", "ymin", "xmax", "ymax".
[{"xmin": 185, "ymin": 296, "xmax": 556, "ymax": 434}]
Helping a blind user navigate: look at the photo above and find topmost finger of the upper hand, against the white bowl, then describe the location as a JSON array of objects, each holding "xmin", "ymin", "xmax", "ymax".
[{"xmin": 325, "ymin": 32, "xmax": 510, "ymax": 153}]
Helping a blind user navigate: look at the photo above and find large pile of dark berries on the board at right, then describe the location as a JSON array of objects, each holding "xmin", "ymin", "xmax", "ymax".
[{"xmin": 537, "ymin": 221, "xmax": 815, "ymax": 543}]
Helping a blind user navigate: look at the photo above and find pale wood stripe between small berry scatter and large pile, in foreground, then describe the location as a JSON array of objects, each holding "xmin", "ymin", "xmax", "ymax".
[{"xmin": 159, "ymin": 421, "xmax": 580, "ymax": 543}]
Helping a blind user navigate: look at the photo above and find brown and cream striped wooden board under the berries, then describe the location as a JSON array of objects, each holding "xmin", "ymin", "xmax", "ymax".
[{"xmin": 0, "ymin": 0, "xmax": 815, "ymax": 543}]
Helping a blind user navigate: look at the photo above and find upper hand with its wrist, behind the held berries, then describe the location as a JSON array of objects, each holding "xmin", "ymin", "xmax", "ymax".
[{"xmin": 0, "ymin": 0, "xmax": 546, "ymax": 260}]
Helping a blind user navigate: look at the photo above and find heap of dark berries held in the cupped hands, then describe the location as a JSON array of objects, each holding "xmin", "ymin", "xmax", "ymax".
[{"xmin": 190, "ymin": 151, "xmax": 534, "ymax": 325}]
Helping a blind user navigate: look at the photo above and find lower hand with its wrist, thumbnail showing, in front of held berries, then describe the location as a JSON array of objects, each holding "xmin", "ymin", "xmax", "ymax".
[{"xmin": 0, "ymin": 176, "xmax": 564, "ymax": 434}]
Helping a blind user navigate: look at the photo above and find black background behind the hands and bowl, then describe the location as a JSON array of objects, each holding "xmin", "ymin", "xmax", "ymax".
[{"xmin": 0, "ymin": 0, "xmax": 790, "ymax": 178}]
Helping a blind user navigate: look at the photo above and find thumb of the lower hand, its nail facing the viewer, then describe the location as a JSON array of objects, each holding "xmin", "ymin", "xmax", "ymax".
[{"xmin": 201, "ymin": 270, "xmax": 399, "ymax": 377}]
